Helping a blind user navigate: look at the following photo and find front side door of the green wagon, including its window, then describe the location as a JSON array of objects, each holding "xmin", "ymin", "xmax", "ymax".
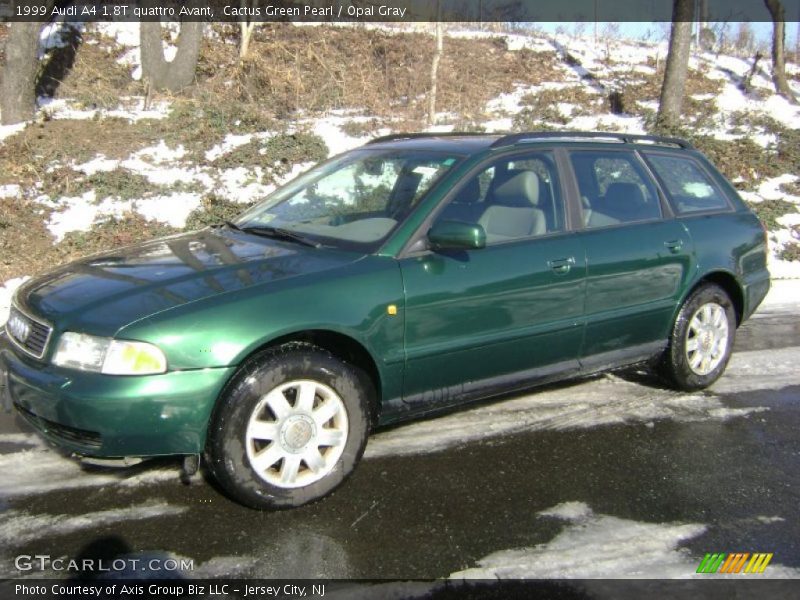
[{"xmin": 400, "ymin": 151, "xmax": 586, "ymax": 410}]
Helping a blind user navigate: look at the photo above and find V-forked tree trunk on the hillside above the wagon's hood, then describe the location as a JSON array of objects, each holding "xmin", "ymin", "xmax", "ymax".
[{"xmin": 139, "ymin": 2, "xmax": 204, "ymax": 92}]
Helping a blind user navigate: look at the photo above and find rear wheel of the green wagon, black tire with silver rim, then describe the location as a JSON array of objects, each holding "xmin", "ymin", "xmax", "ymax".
[{"xmin": 660, "ymin": 284, "xmax": 736, "ymax": 391}]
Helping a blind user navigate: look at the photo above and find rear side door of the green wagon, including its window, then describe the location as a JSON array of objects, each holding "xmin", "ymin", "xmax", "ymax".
[{"xmin": 570, "ymin": 149, "xmax": 694, "ymax": 368}]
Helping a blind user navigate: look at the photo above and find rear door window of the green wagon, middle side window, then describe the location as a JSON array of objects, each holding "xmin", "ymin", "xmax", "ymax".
[{"xmin": 570, "ymin": 152, "xmax": 661, "ymax": 228}]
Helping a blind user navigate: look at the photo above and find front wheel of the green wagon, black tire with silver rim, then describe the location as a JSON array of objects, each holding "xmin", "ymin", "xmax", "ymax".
[{"xmin": 206, "ymin": 343, "xmax": 374, "ymax": 509}]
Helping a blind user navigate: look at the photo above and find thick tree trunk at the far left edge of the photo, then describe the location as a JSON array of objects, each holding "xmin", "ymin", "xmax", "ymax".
[{"xmin": 0, "ymin": 23, "xmax": 42, "ymax": 125}]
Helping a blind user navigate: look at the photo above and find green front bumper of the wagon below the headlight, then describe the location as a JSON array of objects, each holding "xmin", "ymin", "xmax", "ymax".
[{"xmin": 0, "ymin": 333, "xmax": 234, "ymax": 457}]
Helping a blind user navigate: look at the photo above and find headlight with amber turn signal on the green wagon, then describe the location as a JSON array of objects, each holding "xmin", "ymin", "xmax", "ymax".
[{"xmin": 53, "ymin": 331, "xmax": 167, "ymax": 375}]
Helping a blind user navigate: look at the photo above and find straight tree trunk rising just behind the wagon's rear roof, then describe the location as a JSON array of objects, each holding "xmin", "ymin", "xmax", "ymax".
[{"xmin": 657, "ymin": 0, "xmax": 694, "ymax": 127}]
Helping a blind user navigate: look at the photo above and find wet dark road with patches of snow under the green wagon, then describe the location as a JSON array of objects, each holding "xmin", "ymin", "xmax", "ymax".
[{"xmin": 0, "ymin": 300, "xmax": 800, "ymax": 579}]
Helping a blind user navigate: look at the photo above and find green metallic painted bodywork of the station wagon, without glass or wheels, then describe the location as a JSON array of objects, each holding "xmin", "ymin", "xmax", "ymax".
[{"xmin": 0, "ymin": 137, "xmax": 769, "ymax": 456}]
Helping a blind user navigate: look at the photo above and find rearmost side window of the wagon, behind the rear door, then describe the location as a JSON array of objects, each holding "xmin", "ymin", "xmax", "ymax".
[{"xmin": 645, "ymin": 154, "xmax": 728, "ymax": 214}]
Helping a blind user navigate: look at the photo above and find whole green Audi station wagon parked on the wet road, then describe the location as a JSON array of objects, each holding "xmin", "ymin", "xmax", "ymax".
[{"xmin": 0, "ymin": 132, "xmax": 769, "ymax": 508}]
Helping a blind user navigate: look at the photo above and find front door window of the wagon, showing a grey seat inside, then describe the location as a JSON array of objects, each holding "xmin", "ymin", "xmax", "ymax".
[{"xmin": 437, "ymin": 152, "xmax": 564, "ymax": 245}]
